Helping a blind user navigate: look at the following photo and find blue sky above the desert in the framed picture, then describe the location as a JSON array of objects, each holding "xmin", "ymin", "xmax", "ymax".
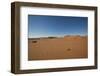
[{"xmin": 28, "ymin": 15, "xmax": 88, "ymax": 38}]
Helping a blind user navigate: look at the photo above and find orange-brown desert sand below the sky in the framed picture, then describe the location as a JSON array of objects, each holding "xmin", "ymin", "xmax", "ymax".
[{"xmin": 28, "ymin": 36, "xmax": 88, "ymax": 60}]
